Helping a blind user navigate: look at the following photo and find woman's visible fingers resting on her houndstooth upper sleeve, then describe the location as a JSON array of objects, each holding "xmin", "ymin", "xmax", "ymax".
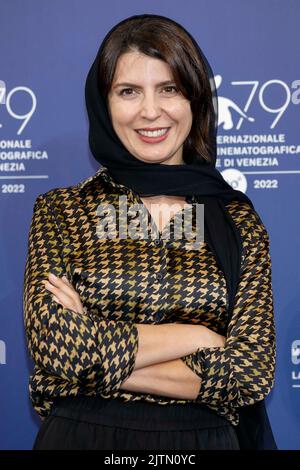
[{"xmin": 42, "ymin": 273, "xmax": 84, "ymax": 314}]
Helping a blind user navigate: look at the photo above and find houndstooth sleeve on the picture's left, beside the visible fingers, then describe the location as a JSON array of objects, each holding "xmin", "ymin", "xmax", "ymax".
[{"xmin": 23, "ymin": 194, "xmax": 138, "ymax": 395}]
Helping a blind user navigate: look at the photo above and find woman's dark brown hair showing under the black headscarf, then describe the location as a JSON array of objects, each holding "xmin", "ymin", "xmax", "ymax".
[{"xmin": 98, "ymin": 15, "xmax": 215, "ymax": 163}]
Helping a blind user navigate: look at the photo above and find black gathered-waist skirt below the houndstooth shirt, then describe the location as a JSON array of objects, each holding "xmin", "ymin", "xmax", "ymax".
[{"xmin": 33, "ymin": 396, "xmax": 239, "ymax": 450}]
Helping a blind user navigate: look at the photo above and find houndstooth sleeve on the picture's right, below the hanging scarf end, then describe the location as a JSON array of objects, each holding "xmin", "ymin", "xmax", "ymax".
[{"xmin": 181, "ymin": 209, "xmax": 276, "ymax": 409}]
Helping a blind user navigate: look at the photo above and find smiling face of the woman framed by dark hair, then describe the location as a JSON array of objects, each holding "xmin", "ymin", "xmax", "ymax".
[{"xmin": 108, "ymin": 52, "xmax": 193, "ymax": 165}]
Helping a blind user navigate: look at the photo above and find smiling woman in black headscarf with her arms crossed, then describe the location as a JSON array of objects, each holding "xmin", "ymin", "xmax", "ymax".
[{"xmin": 24, "ymin": 15, "xmax": 275, "ymax": 450}]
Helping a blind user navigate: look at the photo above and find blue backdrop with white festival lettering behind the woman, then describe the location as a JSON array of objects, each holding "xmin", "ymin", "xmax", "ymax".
[{"xmin": 0, "ymin": 0, "xmax": 300, "ymax": 449}]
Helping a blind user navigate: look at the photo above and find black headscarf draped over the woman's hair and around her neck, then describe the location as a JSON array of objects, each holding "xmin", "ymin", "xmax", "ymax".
[{"xmin": 85, "ymin": 14, "xmax": 276, "ymax": 446}]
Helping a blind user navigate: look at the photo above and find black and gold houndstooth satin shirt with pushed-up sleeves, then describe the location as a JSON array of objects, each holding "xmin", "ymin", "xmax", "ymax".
[{"xmin": 24, "ymin": 167, "xmax": 275, "ymax": 424}]
